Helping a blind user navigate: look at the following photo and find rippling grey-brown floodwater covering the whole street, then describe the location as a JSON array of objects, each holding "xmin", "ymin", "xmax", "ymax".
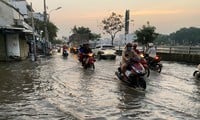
[{"xmin": 0, "ymin": 53, "xmax": 200, "ymax": 120}]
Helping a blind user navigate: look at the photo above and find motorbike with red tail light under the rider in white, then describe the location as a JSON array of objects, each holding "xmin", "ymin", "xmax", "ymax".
[{"xmin": 145, "ymin": 55, "xmax": 162, "ymax": 73}]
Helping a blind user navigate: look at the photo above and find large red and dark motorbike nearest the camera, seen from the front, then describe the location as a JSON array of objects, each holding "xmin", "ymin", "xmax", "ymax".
[{"xmin": 115, "ymin": 59, "xmax": 146, "ymax": 90}]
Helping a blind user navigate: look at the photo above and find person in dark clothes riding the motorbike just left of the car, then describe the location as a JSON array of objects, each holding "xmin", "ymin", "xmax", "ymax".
[{"xmin": 82, "ymin": 43, "xmax": 92, "ymax": 65}]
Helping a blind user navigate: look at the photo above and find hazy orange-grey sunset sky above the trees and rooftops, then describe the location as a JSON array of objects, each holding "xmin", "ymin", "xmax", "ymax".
[{"xmin": 27, "ymin": 0, "xmax": 200, "ymax": 38}]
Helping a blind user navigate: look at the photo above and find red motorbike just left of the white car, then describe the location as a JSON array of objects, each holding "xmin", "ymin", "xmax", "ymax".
[{"xmin": 82, "ymin": 53, "xmax": 96, "ymax": 69}]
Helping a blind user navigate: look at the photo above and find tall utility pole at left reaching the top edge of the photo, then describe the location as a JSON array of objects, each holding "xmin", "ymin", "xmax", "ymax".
[{"xmin": 44, "ymin": 0, "xmax": 49, "ymax": 56}]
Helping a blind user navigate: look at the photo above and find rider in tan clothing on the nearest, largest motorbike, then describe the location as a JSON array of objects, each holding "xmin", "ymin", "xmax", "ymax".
[{"xmin": 121, "ymin": 43, "xmax": 139, "ymax": 76}]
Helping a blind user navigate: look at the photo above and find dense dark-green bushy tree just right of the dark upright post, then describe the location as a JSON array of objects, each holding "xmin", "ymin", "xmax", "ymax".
[{"xmin": 135, "ymin": 22, "xmax": 158, "ymax": 45}]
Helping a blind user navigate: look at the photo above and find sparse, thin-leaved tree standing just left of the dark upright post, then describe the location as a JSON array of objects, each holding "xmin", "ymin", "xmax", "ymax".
[{"xmin": 102, "ymin": 12, "xmax": 124, "ymax": 45}]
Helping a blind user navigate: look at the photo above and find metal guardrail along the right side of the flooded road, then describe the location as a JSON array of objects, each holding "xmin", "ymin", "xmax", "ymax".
[{"xmin": 156, "ymin": 46, "xmax": 200, "ymax": 55}]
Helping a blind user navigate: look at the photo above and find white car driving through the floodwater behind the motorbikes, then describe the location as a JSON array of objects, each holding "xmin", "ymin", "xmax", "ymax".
[{"xmin": 93, "ymin": 44, "xmax": 116, "ymax": 60}]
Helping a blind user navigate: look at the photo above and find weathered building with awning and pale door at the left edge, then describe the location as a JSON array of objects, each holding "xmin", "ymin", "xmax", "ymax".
[{"xmin": 0, "ymin": 0, "xmax": 33, "ymax": 61}]
